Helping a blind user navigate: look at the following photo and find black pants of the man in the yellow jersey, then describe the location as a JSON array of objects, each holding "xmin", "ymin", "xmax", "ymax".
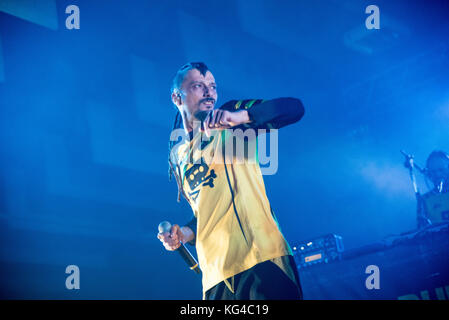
[{"xmin": 205, "ymin": 256, "xmax": 302, "ymax": 300}]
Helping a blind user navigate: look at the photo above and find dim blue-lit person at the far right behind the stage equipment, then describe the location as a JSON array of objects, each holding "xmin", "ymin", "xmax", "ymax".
[{"xmin": 422, "ymin": 150, "xmax": 449, "ymax": 224}]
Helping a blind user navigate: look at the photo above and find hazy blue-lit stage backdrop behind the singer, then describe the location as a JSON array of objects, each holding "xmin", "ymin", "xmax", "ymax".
[{"xmin": 0, "ymin": 0, "xmax": 449, "ymax": 299}]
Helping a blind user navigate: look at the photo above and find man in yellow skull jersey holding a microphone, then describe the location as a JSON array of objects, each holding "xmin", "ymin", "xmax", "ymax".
[{"xmin": 158, "ymin": 62, "xmax": 304, "ymax": 300}]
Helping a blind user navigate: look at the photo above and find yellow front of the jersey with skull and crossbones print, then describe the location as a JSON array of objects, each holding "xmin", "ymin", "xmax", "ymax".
[{"xmin": 174, "ymin": 126, "xmax": 292, "ymax": 296}]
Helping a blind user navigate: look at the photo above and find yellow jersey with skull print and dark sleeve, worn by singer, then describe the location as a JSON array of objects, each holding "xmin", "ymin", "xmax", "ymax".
[{"xmin": 171, "ymin": 98, "xmax": 304, "ymax": 298}]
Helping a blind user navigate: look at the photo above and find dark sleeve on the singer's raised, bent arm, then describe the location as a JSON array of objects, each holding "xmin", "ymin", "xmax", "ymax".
[{"xmin": 220, "ymin": 98, "xmax": 305, "ymax": 129}]
